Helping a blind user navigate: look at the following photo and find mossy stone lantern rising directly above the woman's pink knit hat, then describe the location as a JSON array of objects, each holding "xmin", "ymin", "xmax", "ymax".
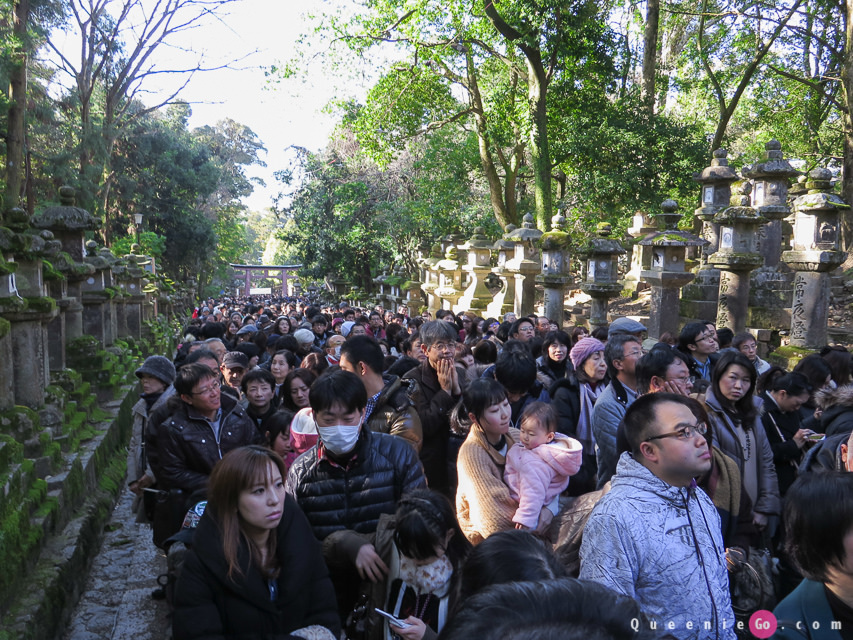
[{"xmin": 578, "ymin": 222, "xmax": 625, "ymax": 329}]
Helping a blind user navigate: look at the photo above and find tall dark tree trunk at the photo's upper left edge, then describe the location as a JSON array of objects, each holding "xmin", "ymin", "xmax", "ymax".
[{"xmin": 3, "ymin": 0, "xmax": 30, "ymax": 216}]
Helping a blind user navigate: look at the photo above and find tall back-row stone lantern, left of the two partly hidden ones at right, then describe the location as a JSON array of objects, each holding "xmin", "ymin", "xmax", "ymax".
[{"xmin": 681, "ymin": 149, "xmax": 738, "ymax": 319}]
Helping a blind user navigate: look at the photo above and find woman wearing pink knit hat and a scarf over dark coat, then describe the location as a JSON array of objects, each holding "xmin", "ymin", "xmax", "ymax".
[{"xmin": 548, "ymin": 338, "xmax": 607, "ymax": 496}]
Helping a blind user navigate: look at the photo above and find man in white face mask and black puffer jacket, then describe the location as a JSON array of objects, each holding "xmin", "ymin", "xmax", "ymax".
[{"xmin": 286, "ymin": 370, "xmax": 426, "ymax": 616}]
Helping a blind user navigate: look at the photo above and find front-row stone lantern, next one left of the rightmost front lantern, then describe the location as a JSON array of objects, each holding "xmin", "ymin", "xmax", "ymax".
[{"xmin": 708, "ymin": 182, "xmax": 767, "ymax": 334}]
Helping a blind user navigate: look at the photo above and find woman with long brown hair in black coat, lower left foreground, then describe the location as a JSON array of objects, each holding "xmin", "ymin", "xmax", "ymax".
[{"xmin": 172, "ymin": 446, "xmax": 340, "ymax": 640}]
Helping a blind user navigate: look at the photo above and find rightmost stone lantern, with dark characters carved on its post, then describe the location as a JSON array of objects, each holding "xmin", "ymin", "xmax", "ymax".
[{"xmin": 782, "ymin": 169, "xmax": 850, "ymax": 349}]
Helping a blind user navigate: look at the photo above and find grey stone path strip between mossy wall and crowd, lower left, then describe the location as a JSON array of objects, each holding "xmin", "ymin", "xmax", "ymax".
[{"xmin": 63, "ymin": 491, "xmax": 171, "ymax": 640}]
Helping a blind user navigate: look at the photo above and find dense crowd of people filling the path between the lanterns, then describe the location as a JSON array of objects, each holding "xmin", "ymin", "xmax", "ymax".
[{"xmin": 128, "ymin": 299, "xmax": 853, "ymax": 640}]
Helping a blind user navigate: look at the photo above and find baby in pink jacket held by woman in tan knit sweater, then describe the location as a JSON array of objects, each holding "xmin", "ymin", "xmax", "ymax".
[{"xmin": 504, "ymin": 402, "xmax": 583, "ymax": 529}]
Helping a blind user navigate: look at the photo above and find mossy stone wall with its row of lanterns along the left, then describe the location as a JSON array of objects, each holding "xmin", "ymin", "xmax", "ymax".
[{"xmin": 0, "ymin": 191, "xmax": 189, "ymax": 640}]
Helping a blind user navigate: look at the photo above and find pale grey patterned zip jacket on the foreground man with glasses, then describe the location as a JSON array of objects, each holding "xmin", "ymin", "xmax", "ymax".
[{"xmin": 580, "ymin": 453, "xmax": 735, "ymax": 640}]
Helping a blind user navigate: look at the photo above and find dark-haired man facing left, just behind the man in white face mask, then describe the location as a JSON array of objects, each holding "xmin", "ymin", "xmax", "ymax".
[{"xmin": 340, "ymin": 336, "xmax": 423, "ymax": 451}]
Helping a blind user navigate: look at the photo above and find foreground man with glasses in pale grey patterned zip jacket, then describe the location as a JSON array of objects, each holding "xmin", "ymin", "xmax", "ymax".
[{"xmin": 580, "ymin": 393, "xmax": 735, "ymax": 640}]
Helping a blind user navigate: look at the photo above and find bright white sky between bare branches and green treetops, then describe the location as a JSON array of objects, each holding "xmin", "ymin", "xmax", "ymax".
[{"xmin": 146, "ymin": 0, "xmax": 364, "ymax": 211}]
